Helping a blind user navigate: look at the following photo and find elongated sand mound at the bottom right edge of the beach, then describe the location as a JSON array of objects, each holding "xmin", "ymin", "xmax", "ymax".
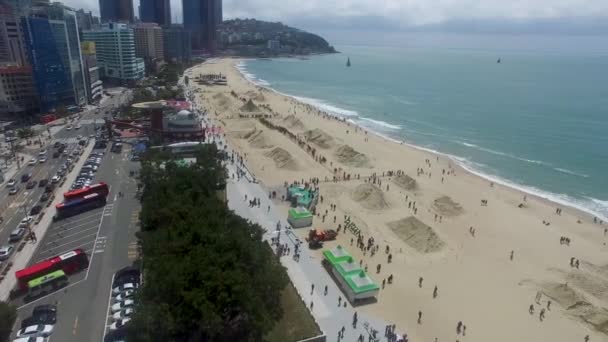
[{"xmin": 543, "ymin": 283, "xmax": 608, "ymax": 335}]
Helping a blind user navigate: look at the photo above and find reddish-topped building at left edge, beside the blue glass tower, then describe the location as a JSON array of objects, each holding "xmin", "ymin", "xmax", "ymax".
[{"xmin": 0, "ymin": 65, "xmax": 38, "ymax": 119}]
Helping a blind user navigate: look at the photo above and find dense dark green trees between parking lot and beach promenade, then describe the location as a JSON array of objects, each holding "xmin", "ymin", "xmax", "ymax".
[{"xmin": 129, "ymin": 145, "xmax": 288, "ymax": 342}]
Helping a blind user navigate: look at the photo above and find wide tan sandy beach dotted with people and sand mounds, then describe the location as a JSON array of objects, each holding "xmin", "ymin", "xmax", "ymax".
[{"xmin": 190, "ymin": 59, "xmax": 608, "ymax": 342}]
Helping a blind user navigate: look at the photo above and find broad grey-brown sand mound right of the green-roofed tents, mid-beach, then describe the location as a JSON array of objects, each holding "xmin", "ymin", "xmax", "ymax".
[{"xmin": 387, "ymin": 216, "xmax": 445, "ymax": 253}]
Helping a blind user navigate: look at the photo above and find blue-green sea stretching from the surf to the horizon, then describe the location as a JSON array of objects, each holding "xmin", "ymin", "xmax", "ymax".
[{"xmin": 239, "ymin": 34, "xmax": 608, "ymax": 219}]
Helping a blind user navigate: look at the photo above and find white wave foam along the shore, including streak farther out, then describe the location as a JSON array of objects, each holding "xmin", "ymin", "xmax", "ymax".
[{"xmin": 236, "ymin": 62, "xmax": 608, "ymax": 221}]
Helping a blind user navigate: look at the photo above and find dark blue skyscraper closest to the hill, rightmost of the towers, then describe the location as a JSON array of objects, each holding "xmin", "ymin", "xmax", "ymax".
[{"xmin": 182, "ymin": 0, "xmax": 222, "ymax": 53}]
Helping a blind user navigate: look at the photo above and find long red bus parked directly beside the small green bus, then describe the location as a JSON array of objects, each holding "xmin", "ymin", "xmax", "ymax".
[{"xmin": 15, "ymin": 248, "xmax": 89, "ymax": 290}]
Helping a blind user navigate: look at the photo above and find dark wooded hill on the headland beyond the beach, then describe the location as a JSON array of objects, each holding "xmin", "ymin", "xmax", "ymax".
[{"xmin": 218, "ymin": 19, "xmax": 337, "ymax": 57}]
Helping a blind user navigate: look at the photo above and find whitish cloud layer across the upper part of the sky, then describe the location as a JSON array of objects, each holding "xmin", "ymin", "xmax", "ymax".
[{"xmin": 65, "ymin": 0, "xmax": 608, "ymax": 26}]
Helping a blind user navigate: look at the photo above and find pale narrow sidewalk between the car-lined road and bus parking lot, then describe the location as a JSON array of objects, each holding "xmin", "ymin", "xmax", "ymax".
[{"xmin": 0, "ymin": 140, "xmax": 95, "ymax": 301}]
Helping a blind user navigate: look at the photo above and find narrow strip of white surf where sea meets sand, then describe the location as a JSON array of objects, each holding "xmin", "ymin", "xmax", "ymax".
[{"xmin": 233, "ymin": 57, "xmax": 608, "ymax": 222}]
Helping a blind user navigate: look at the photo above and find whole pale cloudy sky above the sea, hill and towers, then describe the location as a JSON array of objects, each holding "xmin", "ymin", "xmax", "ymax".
[{"xmin": 64, "ymin": 0, "xmax": 608, "ymax": 34}]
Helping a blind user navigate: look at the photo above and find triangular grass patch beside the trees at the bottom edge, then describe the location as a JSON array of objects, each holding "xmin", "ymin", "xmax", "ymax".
[{"xmin": 264, "ymin": 281, "xmax": 321, "ymax": 342}]
